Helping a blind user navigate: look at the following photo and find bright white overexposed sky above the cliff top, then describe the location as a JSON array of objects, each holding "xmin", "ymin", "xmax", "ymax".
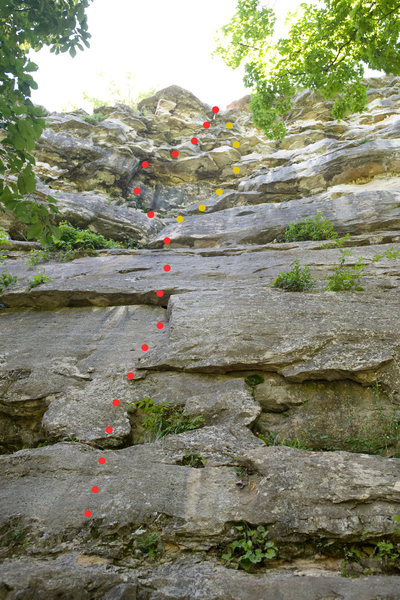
[{"xmin": 29, "ymin": 0, "xmax": 302, "ymax": 112}]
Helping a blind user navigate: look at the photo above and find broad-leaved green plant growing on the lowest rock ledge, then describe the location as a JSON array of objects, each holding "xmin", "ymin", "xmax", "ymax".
[{"xmin": 221, "ymin": 523, "xmax": 278, "ymax": 571}]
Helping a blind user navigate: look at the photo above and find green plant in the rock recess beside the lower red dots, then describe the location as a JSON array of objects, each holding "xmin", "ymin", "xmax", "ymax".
[{"xmin": 128, "ymin": 397, "xmax": 204, "ymax": 442}]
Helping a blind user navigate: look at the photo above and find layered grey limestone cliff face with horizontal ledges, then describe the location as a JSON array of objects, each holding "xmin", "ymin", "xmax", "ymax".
[{"xmin": 0, "ymin": 77, "xmax": 400, "ymax": 600}]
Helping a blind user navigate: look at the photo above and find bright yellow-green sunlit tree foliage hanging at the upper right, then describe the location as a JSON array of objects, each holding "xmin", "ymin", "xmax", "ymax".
[{"xmin": 214, "ymin": 0, "xmax": 400, "ymax": 139}]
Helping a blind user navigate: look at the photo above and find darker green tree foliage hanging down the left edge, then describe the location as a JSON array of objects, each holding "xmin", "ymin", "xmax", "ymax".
[{"xmin": 0, "ymin": 0, "xmax": 91, "ymax": 241}]
